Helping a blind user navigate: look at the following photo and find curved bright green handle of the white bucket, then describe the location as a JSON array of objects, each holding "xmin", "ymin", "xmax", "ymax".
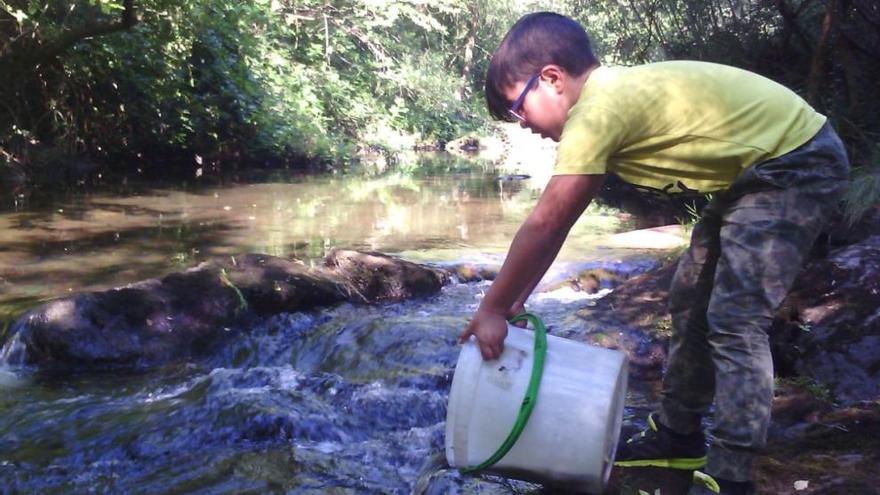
[{"xmin": 459, "ymin": 313, "xmax": 547, "ymax": 473}]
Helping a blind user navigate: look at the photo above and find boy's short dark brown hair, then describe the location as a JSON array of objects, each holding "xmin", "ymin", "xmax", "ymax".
[{"xmin": 486, "ymin": 12, "xmax": 599, "ymax": 121}]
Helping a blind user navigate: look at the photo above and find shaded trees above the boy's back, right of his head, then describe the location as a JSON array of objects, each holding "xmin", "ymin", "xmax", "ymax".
[{"xmin": 561, "ymin": 0, "xmax": 880, "ymax": 163}]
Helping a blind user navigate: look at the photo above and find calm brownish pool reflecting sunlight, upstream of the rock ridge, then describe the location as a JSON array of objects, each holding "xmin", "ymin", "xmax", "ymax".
[{"xmin": 0, "ymin": 162, "xmax": 626, "ymax": 318}]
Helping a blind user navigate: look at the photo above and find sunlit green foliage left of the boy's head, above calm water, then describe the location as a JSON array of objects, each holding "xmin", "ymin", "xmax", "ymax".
[{"xmin": 0, "ymin": 0, "xmax": 513, "ymax": 169}]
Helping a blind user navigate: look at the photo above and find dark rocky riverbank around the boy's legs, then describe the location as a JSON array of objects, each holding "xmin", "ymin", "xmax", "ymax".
[{"xmin": 584, "ymin": 208, "xmax": 880, "ymax": 495}]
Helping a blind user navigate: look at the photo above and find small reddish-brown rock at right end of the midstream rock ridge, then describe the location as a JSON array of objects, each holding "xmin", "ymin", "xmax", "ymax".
[{"xmin": 324, "ymin": 249, "xmax": 448, "ymax": 302}]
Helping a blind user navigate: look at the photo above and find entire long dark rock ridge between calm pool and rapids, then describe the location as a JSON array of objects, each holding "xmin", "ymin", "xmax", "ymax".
[{"xmin": 3, "ymin": 250, "xmax": 448, "ymax": 370}]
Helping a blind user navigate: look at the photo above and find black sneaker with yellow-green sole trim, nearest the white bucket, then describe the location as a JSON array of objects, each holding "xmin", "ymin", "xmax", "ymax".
[{"xmin": 614, "ymin": 413, "xmax": 706, "ymax": 469}]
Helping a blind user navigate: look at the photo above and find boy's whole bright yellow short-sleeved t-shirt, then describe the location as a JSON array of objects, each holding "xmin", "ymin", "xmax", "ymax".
[{"xmin": 554, "ymin": 61, "xmax": 825, "ymax": 193}]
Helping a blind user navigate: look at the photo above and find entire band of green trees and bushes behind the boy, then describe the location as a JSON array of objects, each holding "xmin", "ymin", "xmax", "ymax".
[{"xmin": 0, "ymin": 0, "xmax": 880, "ymax": 210}]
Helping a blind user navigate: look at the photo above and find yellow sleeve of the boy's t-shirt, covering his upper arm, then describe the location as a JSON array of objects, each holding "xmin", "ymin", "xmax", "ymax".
[{"xmin": 553, "ymin": 105, "xmax": 626, "ymax": 175}]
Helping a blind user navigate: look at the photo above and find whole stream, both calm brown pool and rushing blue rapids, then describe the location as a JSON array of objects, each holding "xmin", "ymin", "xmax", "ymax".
[{"xmin": 0, "ymin": 155, "xmax": 653, "ymax": 494}]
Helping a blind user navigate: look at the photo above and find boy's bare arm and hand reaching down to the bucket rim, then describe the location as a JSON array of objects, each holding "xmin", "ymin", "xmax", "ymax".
[{"xmin": 459, "ymin": 175, "xmax": 605, "ymax": 359}]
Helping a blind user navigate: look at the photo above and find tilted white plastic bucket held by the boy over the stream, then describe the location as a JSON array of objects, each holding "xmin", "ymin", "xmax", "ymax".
[{"xmin": 446, "ymin": 326, "xmax": 627, "ymax": 493}]
